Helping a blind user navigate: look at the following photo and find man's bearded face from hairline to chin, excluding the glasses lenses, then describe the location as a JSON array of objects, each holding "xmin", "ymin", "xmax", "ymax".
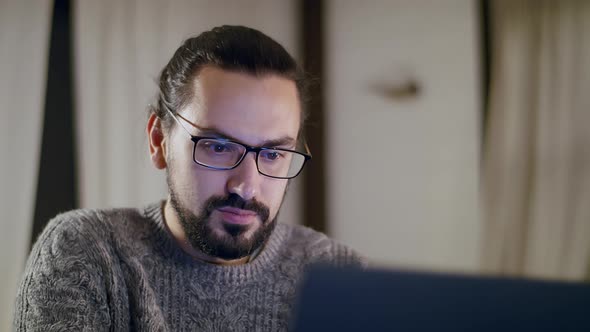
[{"xmin": 166, "ymin": 67, "xmax": 301, "ymax": 260}]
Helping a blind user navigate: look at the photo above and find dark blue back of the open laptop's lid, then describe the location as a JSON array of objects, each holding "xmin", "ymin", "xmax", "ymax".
[{"xmin": 291, "ymin": 266, "xmax": 590, "ymax": 332}]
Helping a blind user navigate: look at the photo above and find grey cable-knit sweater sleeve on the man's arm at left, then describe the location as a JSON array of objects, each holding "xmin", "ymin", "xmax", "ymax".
[{"xmin": 14, "ymin": 212, "xmax": 110, "ymax": 331}]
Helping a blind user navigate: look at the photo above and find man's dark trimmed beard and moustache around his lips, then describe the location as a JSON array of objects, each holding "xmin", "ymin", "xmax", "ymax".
[{"xmin": 166, "ymin": 173, "xmax": 278, "ymax": 260}]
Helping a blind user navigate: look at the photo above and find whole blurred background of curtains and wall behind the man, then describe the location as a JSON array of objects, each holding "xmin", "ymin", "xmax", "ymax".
[{"xmin": 0, "ymin": 0, "xmax": 590, "ymax": 331}]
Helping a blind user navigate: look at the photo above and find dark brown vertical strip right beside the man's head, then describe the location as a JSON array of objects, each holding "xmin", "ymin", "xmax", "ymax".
[{"xmin": 300, "ymin": 0, "xmax": 329, "ymax": 232}]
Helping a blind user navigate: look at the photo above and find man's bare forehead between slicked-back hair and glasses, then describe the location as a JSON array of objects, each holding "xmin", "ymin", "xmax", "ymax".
[{"xmin": 184, "ymin": 67, "xmax": 301, "ymax": 145}]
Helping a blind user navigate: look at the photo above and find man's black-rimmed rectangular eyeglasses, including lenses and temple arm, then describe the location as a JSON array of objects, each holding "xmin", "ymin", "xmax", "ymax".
[{"xmin": 167, "ymin": 109, "xmax": 311, "ymax": 179}]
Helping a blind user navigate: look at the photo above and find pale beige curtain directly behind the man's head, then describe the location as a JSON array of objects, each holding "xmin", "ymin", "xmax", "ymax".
[{"xmin": 74, "ymin": 0, "xmax": 300, "ymax": 222}]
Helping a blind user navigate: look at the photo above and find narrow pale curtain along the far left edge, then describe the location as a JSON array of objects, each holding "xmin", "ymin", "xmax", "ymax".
[{"xmin": 0, "ymin": 0, "xmax": 53, "ymax": 331}]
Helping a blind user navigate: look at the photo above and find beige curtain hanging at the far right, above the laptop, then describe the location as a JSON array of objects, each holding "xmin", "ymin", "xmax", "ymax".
[{"xmin": 482, "ymin": 0, "xmax": 590, "ymax": 280}]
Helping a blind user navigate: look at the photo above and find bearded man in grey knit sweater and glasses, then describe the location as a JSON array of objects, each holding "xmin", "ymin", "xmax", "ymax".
[{"xmin": 15, "ymin": 26, "xmax": 361, "ymax": 331}]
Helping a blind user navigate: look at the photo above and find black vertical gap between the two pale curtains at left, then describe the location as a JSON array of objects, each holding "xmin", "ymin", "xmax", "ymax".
[{"xmin": 31, "ymin": 0, "xmax": 78, "ymax": 249}]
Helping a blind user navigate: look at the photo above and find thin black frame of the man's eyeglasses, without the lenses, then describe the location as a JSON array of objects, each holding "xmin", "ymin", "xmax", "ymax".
[{"xmin": 166, "ymin": 108, "xmax": 311, "ymax": 180}]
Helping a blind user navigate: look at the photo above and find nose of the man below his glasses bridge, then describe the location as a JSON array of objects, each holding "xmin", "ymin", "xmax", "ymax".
[{"xmin": 227, "ymin": 152, "xmax": 263, "ymax": 201}]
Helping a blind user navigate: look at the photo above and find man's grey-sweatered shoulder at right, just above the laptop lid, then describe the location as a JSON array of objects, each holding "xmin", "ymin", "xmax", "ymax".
[{"xmin": 277, "ymin": 224, "xmax": 366, "ymax": 266}]
